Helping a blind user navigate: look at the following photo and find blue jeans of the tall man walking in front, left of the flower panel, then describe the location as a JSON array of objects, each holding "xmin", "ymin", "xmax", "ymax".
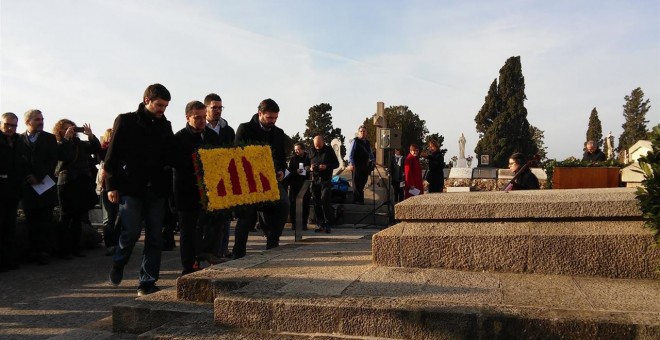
[{"xmin": 112, "ymin": 192, "xmax": 166, "ymax": 287}]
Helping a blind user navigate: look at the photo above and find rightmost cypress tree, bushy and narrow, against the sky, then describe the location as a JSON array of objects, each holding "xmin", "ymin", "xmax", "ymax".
[{"xmin": 618, "ymin": 87, "xmax": 651, "ymax": 151}]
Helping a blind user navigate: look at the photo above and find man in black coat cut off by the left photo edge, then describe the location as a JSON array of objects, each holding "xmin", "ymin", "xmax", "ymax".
[{"xmin": 0, "ymin": 112, "xmax": 25, "ymax": 272}]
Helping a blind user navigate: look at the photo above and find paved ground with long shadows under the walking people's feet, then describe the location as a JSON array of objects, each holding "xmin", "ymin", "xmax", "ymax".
[{"xmin": 0, "ymin": 225, "xmax": 378, "ymax": 339}]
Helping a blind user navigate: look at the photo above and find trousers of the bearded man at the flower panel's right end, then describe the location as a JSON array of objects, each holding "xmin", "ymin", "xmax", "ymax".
[{"xmin": 232, "ymin": 183, "xmax": 289, "ymax": 258}]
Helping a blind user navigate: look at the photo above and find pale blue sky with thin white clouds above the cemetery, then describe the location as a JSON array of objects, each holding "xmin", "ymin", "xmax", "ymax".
[{"xmin": 0, "ymin": 0, "xmax": 660, "ymax": 161}]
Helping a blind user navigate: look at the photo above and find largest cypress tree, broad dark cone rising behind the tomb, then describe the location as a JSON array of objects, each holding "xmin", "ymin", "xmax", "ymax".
[{"xmin": 474, "ymin": 56, "xmax": 538, "ymax": 168}]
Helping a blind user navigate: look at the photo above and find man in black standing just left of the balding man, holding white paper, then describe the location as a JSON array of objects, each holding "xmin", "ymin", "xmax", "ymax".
[{"xmin": 286, "ymin": 143, "xmax": 311, "ymax": 230}]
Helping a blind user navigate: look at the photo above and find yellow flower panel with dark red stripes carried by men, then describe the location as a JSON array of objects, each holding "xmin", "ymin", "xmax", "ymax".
[{"xmin": 193, "ymin": 145, "xmax": 280, "ymax": 211}]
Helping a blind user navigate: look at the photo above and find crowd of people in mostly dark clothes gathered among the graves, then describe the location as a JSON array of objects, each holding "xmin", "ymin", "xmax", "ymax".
[{"xmin": 0, "ymin": 84, "xmax": 538, "ymax": 296}]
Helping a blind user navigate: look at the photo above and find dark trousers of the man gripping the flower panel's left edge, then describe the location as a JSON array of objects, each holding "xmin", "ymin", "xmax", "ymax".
[{"xmin": 179, "ymin": 210, "xmax": 202, "ymax": 272}]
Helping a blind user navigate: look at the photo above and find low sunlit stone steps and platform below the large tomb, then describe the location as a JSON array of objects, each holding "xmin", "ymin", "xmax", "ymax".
[{"xmin": 113, "ymin": 239, "xmax": 660, "ymax": 339}]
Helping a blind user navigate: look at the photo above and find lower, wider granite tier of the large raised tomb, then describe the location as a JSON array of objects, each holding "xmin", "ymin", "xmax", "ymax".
[{"xmin": 373, "ymin": 220, "xmax": 660, "ymax": 279}]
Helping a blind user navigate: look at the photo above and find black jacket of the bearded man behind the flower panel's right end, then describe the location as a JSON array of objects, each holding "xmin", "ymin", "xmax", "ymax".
[{"xmin": 234, "ymin": 113, "xmax": 286, "ymax": 172}]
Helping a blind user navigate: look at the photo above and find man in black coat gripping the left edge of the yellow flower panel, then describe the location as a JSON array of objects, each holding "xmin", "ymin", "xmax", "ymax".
[{"xmin": 174, "ymin": 101, "xmax": 220, "ymax": 275}]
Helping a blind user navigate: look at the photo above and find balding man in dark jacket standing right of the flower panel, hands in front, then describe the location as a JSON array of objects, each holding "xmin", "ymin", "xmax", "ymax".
[{"xmin": 309, "ymin": 136, "xmax": 339, "ymax": 233}]
